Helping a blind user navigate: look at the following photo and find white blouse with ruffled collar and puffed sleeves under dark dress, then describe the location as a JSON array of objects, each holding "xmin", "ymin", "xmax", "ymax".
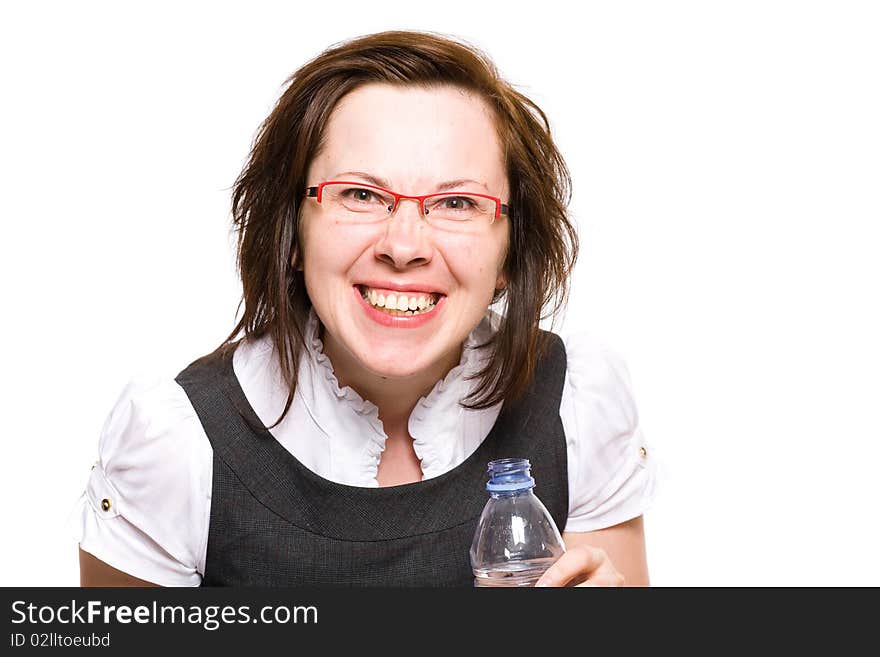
[{"xmin": 68, "ymin": 310, "xmax": 656, "ymax": 586}]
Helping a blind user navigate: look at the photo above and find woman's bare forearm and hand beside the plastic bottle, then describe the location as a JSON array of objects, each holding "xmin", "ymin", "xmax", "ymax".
[{"xmin": 540, "ymin": 516, "xmax": 650, "ymax": 586}]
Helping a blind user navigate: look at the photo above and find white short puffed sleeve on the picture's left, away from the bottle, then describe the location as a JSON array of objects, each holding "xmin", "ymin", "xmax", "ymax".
[{"xmin": 68, "ymin": 376, "xmax": 212, "ymax": 586}]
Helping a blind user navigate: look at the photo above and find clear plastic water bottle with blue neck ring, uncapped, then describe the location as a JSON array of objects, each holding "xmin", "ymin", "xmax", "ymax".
[{"xmin": 470, "ymin": 459, "xmax": 565, "ymax": 586}]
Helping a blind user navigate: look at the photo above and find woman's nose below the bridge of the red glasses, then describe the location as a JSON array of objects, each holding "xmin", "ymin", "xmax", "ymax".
[{"xmin": 374, "ymin": 198, "xmax": 434, "ymax": 269}]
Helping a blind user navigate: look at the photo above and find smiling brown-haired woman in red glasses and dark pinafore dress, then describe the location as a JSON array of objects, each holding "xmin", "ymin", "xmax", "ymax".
[{"xmin": 79, "ymin": 32, "xmax": 653, "ymax": 586}]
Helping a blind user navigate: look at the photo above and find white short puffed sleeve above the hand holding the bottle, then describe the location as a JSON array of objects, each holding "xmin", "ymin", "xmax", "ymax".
[{"xmin": 559, "ymin": 331, "xmax": 656, "ymax": 532}]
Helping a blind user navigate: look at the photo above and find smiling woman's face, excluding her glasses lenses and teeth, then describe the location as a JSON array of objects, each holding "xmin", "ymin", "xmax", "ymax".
[{"xmin": 300, "ymin": 83, "xmax": 509, "ymax": 379}]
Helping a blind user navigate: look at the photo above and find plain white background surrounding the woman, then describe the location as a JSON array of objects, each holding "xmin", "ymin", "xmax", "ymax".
[{"xmin": 0, "ymin": 0, "xmax": 880, "ymax": 586}]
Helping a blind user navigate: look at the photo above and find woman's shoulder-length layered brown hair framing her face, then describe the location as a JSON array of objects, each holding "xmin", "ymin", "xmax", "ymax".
[{"xmin": 217, "ymin": 31, "xmax": 578, "ymax": 426}]
